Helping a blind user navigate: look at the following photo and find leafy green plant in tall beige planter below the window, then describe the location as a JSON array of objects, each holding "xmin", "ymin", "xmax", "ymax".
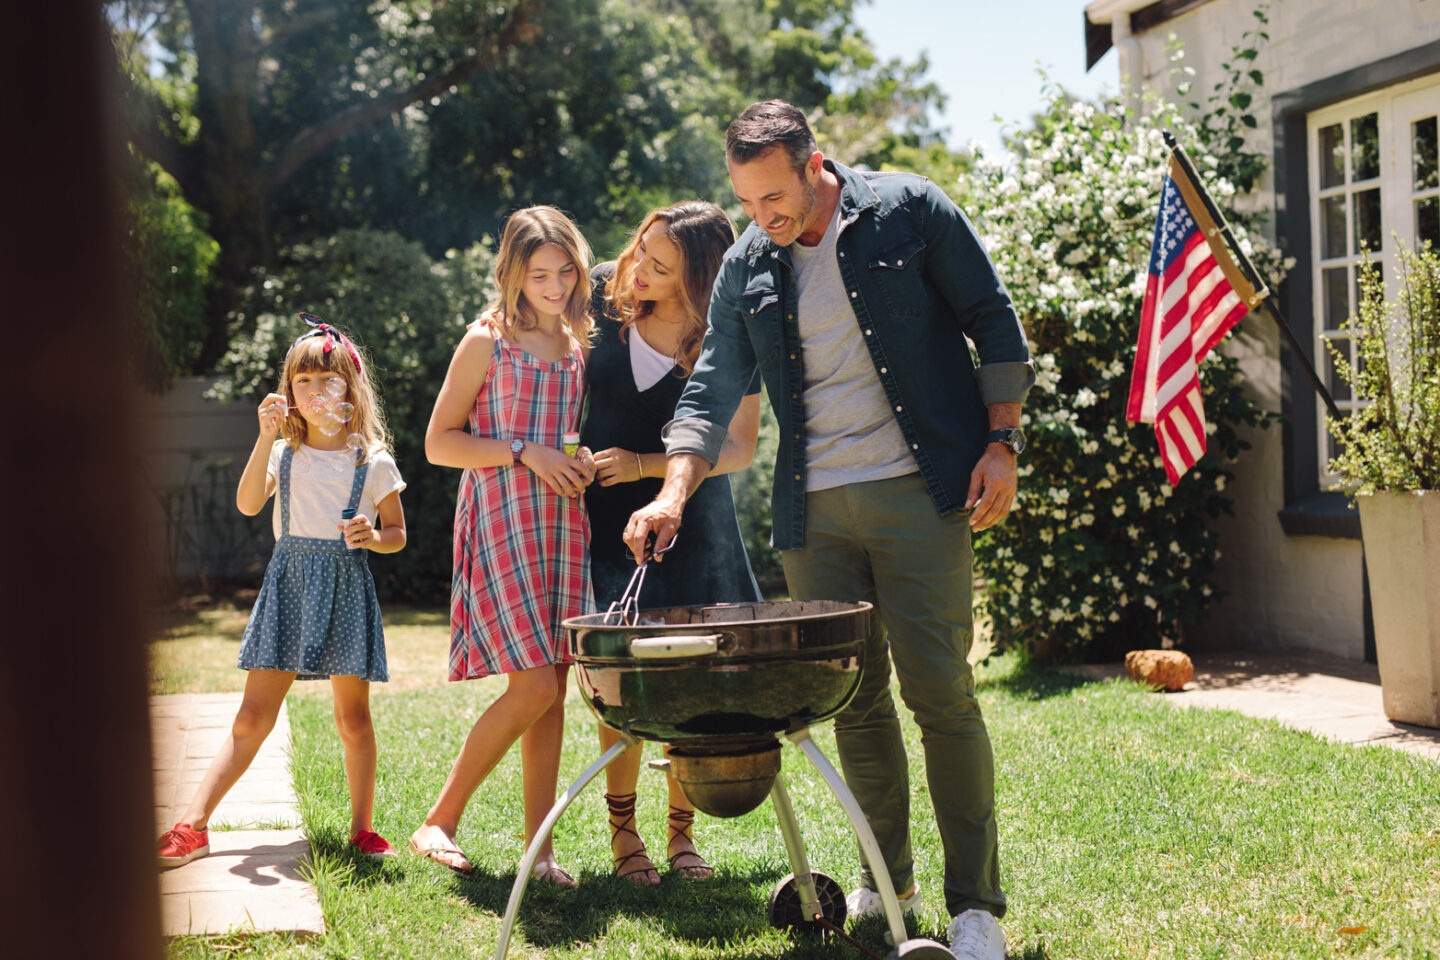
[{"xmin": 1329, "ymin": 245, "xmax": 1440, "ymax": 727}]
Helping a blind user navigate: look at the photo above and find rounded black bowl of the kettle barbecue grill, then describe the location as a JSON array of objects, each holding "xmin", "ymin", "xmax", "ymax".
[{"xmin": 564, "ymin": 600, "xmax": 871, "ymax": 744}]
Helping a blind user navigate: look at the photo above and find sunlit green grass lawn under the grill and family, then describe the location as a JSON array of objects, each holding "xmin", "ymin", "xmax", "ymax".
[{"xmin": 157, "ymin": 612, "xmax": 1440, "ymax": 960}]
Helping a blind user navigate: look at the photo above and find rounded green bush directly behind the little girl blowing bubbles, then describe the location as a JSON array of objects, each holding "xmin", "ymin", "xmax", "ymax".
[{"xmin": 215, "ymin": 230, "xmax": 494, "ymax": 603}]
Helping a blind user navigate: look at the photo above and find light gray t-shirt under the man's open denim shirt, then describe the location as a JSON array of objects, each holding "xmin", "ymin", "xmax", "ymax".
[{"xmin": 789, "ymin": 203, "xmax": 919, "ymax": 491}]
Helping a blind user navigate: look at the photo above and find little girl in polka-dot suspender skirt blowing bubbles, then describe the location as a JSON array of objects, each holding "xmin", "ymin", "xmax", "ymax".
[{"xmin": 160, "ymin": 314, "xmax": 405, "ymax": 866}]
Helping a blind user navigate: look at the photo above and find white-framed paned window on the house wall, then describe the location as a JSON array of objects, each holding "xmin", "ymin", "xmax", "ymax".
[{"xmin": 1306, "ymin": 76, "xmax": 1440, "ymax": 488}]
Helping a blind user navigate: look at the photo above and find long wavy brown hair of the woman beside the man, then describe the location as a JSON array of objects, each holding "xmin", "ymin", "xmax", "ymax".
[{"xmin": 605, "ymin": 200, "xmax": 734, "ymax": 377}]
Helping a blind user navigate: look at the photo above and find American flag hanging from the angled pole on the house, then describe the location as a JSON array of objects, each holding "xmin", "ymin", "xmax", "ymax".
[{"xmin": 1125, "ymin": 153, "xmax": 1264, "ymax": 486}]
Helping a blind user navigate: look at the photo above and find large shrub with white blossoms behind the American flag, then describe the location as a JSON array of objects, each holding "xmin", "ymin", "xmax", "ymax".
[{"xmin": 959, "ymin": 92, "xmax": 1280, "ymax": 656}]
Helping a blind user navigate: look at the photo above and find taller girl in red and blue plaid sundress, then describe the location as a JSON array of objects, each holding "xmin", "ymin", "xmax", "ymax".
[{"xmin": 410, "ymin": 206, "xmax": 595, "ymax": 887}]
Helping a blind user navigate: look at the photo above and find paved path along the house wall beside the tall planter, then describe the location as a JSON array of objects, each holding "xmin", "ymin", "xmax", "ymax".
[{"xmin": 1079, "ymin": 653, "xmax": 1440, "ymax": 760}]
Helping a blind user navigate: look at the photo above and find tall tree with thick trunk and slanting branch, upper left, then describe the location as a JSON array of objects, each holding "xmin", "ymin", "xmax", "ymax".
[{"xmin": 115, "ymin": 0, "xmax": 552, "ymax": 366}]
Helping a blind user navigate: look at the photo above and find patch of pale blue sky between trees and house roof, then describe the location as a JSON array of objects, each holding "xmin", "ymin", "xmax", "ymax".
[{"xmin": 855, "ymin": 0, "xmax": 1119, "ymax": 150}]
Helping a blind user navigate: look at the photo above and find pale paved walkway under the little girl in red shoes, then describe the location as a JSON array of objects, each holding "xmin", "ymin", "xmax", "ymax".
[{"xmin": 150, "ymin": 694, "xmax": 325, "ymax": 937}]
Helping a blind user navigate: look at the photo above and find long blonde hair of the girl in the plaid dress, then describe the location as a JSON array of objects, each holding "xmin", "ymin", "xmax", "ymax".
[{"xmin": 484, "ymin": 206, "xmax": 595, "ymax": 344}]
